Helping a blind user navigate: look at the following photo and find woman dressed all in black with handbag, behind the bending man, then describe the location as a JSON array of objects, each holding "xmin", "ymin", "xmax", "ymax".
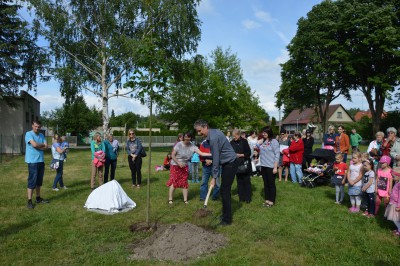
[{"xmin": 230, "ymin": 129, "xmax": 252, "ymax": 203}]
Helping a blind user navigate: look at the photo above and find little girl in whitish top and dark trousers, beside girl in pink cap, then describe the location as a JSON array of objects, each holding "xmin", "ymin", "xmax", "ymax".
[{"xmin": 361, "ymin": 159, "xmax": 375, "ymax": 218}]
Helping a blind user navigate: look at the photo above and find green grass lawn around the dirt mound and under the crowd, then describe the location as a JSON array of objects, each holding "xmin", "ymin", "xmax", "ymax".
[{"xmin": 0, "ymin": 148, "xmax": 400, "ymax": 265}]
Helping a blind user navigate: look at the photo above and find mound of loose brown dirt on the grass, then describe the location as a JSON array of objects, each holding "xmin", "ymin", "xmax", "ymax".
[{"xmin": 130, "ymin": 223, "xmax": 228, "ymax": 261}]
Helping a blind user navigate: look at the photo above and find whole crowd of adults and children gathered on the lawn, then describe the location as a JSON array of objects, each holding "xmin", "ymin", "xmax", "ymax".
[{"xmin": 25, "ymin": 120, "xmax": 400, "ymax": 236}]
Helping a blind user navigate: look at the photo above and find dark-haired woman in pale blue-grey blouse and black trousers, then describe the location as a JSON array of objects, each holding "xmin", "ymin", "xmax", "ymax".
[{"xmin": 257, "ymin": 126, "xmax": 280, "ymax": 207}]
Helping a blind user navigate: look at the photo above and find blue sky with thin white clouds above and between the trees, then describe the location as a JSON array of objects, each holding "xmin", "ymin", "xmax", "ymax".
[{"xmin": 28, "ymin": 0, "xmax": 367, "ymax": 119}]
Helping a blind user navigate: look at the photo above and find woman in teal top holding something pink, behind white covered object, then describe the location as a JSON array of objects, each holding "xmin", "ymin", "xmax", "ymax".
[{"xmin": 90, "ymin": 132, "xmax": 106, "ymax": 190}]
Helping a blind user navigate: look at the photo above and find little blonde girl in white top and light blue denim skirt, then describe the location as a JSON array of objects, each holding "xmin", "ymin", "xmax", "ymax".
[{"xmin": 347, "ymin": 152, "xmax": 362, "ymax": 213}]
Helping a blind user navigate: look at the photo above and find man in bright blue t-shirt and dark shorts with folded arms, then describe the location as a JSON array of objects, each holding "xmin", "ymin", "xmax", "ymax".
[{"xmin": 25, "ymin": 120, "xmax": 49, "ymax": 209}]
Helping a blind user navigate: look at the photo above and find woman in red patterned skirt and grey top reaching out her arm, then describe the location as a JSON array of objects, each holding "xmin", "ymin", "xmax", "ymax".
[{"xmin": 167, "ymin": 131, "xmax": 211, "ymax": 204}]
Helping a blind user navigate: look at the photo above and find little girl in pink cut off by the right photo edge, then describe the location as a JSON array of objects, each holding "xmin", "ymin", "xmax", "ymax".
[{"xmin": 385, "ymin": 167, "xmax": 400, "ymax": 236}]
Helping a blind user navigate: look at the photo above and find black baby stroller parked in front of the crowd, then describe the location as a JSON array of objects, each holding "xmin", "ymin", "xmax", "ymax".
[{"xmin": 302, "ymin": 149, "xmax": 335, "ymax": 188}]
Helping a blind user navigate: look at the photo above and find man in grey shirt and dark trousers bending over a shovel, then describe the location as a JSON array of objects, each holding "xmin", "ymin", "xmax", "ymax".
[{"xmin": 194, "ymin": 120, "xmax": 238, "ymax": 225}]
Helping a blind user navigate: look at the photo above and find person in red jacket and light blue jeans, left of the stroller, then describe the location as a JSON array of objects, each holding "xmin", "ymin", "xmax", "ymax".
[{"xmin": 289, "ymin": 132, "xmax": 304, "ymax": 184}]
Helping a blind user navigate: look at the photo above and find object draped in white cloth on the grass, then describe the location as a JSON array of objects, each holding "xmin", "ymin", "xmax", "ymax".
[{"xmin": 84, "ymin": 180, "xmax": 136, "ymax": 214}]
